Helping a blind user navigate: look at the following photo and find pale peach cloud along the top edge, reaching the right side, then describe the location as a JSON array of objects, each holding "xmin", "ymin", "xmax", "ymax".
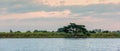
[{"xmin": 33, "ymin": 0, "xmax": 120, "ymax": 7}]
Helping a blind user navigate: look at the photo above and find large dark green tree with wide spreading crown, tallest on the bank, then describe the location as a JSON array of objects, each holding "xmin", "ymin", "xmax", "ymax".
[{"xmin": 58, "ymin": 23, "xmax": 89, "ymax": 35}]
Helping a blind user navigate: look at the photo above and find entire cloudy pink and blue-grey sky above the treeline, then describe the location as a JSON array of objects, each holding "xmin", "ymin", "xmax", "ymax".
[{"xmin": 0, "ymin": 0, "xmax": 120, "ymax": 32}]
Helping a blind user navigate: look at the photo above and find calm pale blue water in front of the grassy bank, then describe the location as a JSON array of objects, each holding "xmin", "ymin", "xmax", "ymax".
[{"xmin": 0, "ymin": 38, "xmax": 120, "ymax": 51}]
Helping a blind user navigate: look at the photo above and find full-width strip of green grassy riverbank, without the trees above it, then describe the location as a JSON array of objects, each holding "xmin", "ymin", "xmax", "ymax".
[{"xmin": 0, "ymin": 33, "xmax": 120, "ymax": 38}]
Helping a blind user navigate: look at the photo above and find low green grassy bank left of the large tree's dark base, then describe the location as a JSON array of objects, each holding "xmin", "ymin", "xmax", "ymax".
[{"xmin": 0, "ymin": 34, "xmax": 67, "ymax": 38}]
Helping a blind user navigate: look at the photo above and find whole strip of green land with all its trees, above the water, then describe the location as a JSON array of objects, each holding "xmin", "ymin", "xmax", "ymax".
[{"xmin": 0, "ymin": 23, "xmax": 120, "ymax": 38}]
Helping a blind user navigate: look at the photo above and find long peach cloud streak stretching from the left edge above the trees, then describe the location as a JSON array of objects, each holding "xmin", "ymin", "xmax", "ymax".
[{"xmin": 0, "ymin": 10, "xmax": 77, "ymax": 20}]
